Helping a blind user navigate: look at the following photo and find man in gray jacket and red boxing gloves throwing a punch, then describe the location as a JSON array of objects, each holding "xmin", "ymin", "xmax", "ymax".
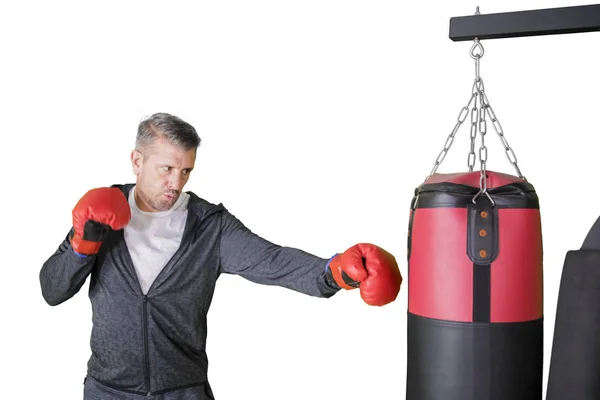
[{"xmin": 40, "ymin": 113, "xmax": 402, "ymax": 400}]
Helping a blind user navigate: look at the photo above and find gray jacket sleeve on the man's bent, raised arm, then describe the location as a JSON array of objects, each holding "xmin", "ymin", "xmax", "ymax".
[{"xmin": 39, "ymin": 228, "xmax": 96, "ymax": 306}]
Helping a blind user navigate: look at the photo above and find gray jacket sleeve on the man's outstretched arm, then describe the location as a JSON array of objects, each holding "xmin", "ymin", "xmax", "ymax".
[{"xmin": 220, "ymin": 211, "xmax": 340, "ymax": 298}]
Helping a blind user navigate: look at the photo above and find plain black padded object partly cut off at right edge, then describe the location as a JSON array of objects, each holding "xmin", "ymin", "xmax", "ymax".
[{"xmin": 546, "ymin": 217, "xmax": 600, "ymax": 400}]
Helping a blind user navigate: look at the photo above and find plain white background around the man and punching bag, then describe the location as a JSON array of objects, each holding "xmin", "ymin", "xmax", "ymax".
[{"xmin": 0, "ymin": 0, "xmax": 600, "ymax": 400}]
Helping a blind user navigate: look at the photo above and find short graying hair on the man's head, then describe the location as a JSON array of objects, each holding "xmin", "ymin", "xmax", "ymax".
[{"xmin": 135, "ymin": 113, "xmax": 200, "ymax": 151}]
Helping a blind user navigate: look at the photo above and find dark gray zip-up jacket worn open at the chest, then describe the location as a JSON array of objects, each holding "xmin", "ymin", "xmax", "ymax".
[{"xmin": 40, "ymin": 184, "xmax": 340, "ymax": 394}]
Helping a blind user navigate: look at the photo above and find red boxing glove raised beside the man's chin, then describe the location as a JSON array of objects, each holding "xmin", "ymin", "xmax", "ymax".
[{"xmin": 71, "ymin": 187, "xmax": 131, "ymax": 255}]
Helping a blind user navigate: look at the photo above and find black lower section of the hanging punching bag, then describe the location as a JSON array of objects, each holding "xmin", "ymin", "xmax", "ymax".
[{"xmin": 406, "ymin": 313, "xmax": 544, "ymax": 400}]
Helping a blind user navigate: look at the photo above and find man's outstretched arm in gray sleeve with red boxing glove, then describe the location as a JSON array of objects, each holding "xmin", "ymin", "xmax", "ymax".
[{"xmin": 221, "ymin": 211, "xmax": 402, "ymax": 306}]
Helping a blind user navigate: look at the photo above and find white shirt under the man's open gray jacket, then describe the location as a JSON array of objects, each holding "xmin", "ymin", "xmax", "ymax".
[{"xmin": 124, "ymin": 186, "xmax": 189, "ymax": 294}]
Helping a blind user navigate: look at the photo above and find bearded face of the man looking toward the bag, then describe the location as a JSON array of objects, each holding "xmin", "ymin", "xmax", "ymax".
[{"xmin": 131, "ymin": 138, "xmax": 196, "ymax": 211}]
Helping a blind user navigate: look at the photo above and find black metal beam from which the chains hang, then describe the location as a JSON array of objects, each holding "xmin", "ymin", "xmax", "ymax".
[{"xmin": 450, "ymin": 4, "xmax": 600, "ymax": 42}]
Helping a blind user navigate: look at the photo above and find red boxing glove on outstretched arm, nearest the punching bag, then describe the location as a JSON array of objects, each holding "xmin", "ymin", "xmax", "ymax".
[{"xmin": 327, "ymin": 243, "xmax": 402, "ymax": 306}]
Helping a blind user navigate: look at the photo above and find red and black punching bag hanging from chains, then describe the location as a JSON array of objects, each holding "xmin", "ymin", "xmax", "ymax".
[{"xmin": 406, "ymin": 171, "xmax": 543, "ymax": 400}]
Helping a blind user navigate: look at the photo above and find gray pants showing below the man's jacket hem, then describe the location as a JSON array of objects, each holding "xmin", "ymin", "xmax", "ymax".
[{"xmin": 83, "ymin": 376, "xmax": 215, "ymax": 400}]
